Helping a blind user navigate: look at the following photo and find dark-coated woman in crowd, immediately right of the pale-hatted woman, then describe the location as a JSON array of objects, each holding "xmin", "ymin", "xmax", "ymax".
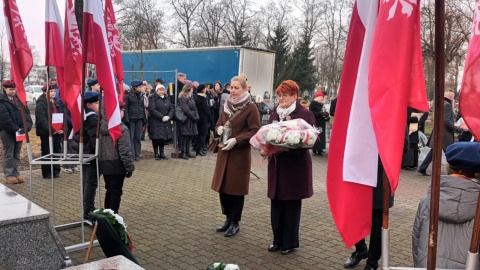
[{"xmin": 178, "ymin": 84, "xmax": 199, "ymax": 159}]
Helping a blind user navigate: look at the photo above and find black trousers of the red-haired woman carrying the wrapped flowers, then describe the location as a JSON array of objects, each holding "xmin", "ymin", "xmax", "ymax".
[{"xmin": 270, "ymin": 199, "xmax": 302, "ymax": 249}]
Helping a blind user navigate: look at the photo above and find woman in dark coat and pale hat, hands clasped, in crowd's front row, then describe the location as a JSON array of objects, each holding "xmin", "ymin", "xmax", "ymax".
[{"xmin": 148, "ymin": 84, "xmax": 174, "ymax": 160}]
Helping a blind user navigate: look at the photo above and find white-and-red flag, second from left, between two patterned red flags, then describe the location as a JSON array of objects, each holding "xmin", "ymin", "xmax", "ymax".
[{"xmin": 45, "ymin": 0, "xmax": 66, "ymax": 103}]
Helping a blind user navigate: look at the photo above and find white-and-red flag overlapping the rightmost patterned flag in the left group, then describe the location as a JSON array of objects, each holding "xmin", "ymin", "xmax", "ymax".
[{"xmin": 82, "ymin": 0, "xmax": 122, "ymax": 142}]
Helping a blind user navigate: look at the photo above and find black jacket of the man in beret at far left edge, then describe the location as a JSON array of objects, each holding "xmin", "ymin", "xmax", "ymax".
[{"xmin": 0, "ymin": 93, "xmax": 33, "ymax": 133}]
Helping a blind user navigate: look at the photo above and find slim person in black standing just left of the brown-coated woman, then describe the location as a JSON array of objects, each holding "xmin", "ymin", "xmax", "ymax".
[{"xmin": 195, "ymin": 84, "xmax": 213, "ymax": 156}]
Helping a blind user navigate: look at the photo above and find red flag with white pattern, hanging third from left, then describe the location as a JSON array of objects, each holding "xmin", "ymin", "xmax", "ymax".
[{"xmin": 63, "ymin": 0, "xmax": 83, "ymax": 135}]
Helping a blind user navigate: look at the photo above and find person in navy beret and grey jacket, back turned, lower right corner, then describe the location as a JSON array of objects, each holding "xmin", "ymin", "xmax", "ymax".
[{"xmin": 412, "ymin": 142, "xmax": 480, "ymax": 269}]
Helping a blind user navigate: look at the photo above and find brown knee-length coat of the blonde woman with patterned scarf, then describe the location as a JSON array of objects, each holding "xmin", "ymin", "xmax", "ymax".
[{"xmin": 212, "ymin": 103, "xmax": 260, "ymax": 195}]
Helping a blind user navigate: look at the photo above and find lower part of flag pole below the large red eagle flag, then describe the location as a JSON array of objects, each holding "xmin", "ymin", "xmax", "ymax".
[{"xmin": 382, "ymin": 170, "xmax": 390, "ymax": 269}]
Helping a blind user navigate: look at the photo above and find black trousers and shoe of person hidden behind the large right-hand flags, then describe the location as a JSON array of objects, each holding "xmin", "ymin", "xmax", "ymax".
[{"xmin": 355, "ymin": 209, "xmax": 382, "ymax": 269}]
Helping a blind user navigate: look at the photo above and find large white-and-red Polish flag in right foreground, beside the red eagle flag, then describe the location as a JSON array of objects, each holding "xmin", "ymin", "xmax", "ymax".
[{"xmin": 327, "ymin": 0, "xmax": 378, "ymax": 247}]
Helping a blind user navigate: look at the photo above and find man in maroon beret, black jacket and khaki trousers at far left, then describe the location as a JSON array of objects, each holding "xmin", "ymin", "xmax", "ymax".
[{"xmin": 0, "ymin": 80, "xmax": 33, "ymax": 184}]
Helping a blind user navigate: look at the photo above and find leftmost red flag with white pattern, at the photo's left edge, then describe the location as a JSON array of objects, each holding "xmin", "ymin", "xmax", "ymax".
[{"xmin": 3, "ymin": 0, "xmax": 33, "ymax": 105}]
